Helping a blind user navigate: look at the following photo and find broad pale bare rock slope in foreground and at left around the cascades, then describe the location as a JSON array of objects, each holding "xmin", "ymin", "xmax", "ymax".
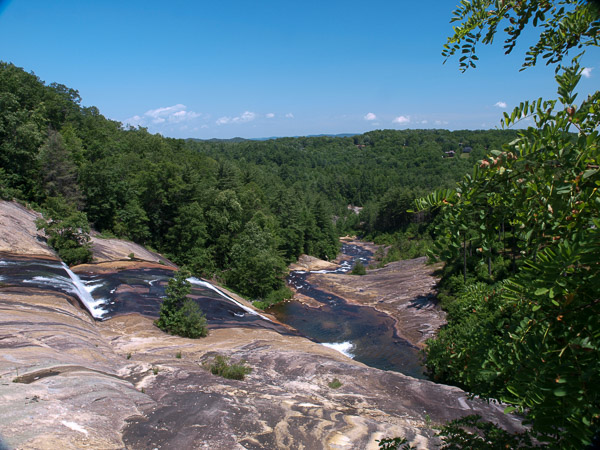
[{"xmin": 0, "ymin": 202, "xmax": 519, "ymax": 449}]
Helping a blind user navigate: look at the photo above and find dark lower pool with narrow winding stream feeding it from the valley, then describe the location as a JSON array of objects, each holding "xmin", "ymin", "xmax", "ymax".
[{"xmin": 269, "ymin": 244, "xmax": 425, "ymax": 378}]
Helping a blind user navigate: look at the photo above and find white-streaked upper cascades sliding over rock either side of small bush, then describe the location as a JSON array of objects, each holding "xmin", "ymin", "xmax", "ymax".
[{"xmin": 0, "ymin": 258, "xmax": 290, "ymax": 334}]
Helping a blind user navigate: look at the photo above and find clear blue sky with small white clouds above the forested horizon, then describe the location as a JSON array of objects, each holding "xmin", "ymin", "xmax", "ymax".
[{"xmin": 0, "ymin": 0, "xmax": 600, "ymax": 139}]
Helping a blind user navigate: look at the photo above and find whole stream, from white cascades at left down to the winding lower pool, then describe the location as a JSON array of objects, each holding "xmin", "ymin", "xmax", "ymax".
[{"xmin": 0, "ymin": 248, "xmax": 424, "ymax": 378}]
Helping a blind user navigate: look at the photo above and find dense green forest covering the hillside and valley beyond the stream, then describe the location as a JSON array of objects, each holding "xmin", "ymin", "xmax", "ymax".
[{"xmin": 0, "ymin": 59, "xmax": 516, "ymax": 299}]
